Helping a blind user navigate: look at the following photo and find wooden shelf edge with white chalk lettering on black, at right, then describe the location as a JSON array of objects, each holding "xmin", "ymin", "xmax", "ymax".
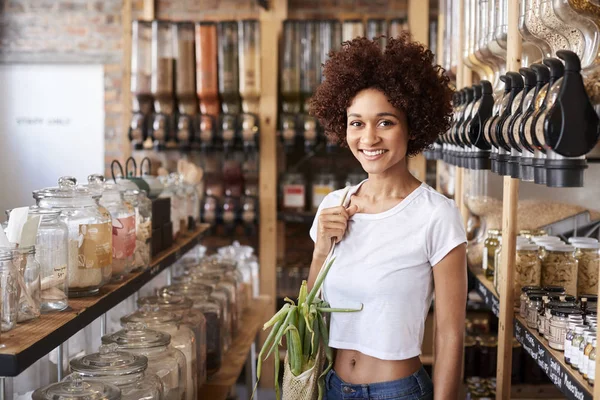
[{"xmin": 469, "ymin": 268, "xmax": 593, "ymax": 400}]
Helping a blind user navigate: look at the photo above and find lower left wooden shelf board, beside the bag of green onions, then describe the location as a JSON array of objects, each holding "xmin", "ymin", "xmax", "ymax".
[{"xmin": 198, "ymin": 295, "xmax": 272, "ymax": 400}]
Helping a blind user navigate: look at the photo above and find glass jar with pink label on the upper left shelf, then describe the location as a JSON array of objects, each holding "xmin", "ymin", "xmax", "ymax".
[{"xmin": 95, "ymin": 177, "xmax": 136, "ymax": 281}]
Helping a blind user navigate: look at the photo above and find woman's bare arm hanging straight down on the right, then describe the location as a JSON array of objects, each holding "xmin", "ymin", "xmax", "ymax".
[{"xmin": 433, "ymin": 244, "xmax": 467, "ymax": 400}]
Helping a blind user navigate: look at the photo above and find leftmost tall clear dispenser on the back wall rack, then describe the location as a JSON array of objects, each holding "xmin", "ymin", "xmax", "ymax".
[{"xmin": 129, "ymin": 21, "xmax": 153, "ymax": 150}]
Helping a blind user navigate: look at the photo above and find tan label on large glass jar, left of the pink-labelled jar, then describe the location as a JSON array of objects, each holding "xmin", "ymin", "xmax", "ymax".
[{"xmin": 77, "ymin": 223, "xmax": 112, "ymax": 269}]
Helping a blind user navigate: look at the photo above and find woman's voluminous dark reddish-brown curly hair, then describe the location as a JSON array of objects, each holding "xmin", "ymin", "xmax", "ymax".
[{"xmin": 310, "ymin": 33, "xmax": 453, "ymax": 157}]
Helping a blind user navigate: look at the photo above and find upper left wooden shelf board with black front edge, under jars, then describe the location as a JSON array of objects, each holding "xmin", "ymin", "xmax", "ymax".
[{"xmin": 0, "ymin": 224, "xmax": 208, "ymax": 377}]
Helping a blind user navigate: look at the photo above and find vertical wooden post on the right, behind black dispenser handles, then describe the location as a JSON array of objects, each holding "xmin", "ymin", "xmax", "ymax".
[{"xmin": 496, "ymin": 0, "xmax": 522, "ymax": 399}]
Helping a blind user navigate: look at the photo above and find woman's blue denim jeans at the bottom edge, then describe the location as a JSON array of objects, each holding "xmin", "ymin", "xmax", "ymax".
[{"xmin": 324, "ymin": 367, "xmax": 433, "ymax": 400}]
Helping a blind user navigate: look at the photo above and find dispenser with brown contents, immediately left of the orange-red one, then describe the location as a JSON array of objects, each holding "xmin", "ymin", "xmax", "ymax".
[{"xmin": 174, "ymin": 22, "xmax": 198, "ymax": 150}]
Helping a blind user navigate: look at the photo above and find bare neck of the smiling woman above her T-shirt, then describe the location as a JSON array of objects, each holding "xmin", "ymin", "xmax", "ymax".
[{"xmin": 360, "ymin": 159, "xmax": 421, "ymax": 201}]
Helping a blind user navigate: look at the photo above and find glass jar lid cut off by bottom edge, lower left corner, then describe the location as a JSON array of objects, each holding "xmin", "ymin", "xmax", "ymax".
[{"xmin": 31, "ymin": 373, "xmax": 121, "ymax": 400}]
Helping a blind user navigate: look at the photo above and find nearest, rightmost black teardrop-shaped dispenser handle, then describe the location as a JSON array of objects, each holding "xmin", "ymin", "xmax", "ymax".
[{"xmin": 544, "ymin": 50, "xmax": 600, "ymax": 157}]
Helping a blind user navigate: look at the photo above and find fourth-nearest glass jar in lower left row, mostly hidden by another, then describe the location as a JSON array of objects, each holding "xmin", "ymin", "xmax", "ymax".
[{"xmin": 121, "ymin": 305, "xmax": 198, "ymax": 400}]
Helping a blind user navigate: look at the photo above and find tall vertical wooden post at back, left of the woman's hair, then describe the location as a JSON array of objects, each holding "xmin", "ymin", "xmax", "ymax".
[{"xmin": 258, "ymin": 0, "xmax": 287, "ymax": 387}]
